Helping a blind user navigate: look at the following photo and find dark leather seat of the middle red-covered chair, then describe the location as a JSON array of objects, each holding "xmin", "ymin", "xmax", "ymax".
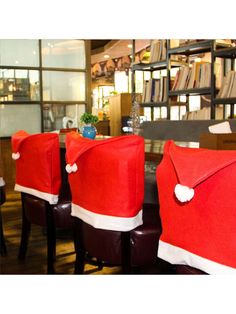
[{"xmin": 82, "ymin": 205, "xmax": 161, "ymax": 266}]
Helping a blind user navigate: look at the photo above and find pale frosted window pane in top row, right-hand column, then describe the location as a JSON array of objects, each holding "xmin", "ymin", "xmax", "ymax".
[{"xmin": 42, "ymin": 39, "xmax": 86, "ymax": 69}]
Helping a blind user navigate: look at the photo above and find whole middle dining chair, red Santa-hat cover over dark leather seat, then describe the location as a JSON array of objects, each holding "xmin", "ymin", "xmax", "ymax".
[{"xmin": 66, "ymin": 133, "xmax": 161, "ymax": 274}]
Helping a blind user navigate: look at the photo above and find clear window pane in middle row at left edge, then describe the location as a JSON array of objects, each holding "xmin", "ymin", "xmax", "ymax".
[{"xmin": 0, "ymin": 69, "xmax": 40, "ymax": 101}]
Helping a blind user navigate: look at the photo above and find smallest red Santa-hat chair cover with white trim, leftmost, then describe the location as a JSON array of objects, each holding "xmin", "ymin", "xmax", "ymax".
[{"xmin": 12, "ymin": 131, "xmax": 61, "ymax": 204}]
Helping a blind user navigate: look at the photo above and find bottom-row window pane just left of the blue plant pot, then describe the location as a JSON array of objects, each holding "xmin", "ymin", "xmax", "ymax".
[{"xmin": 43, "ymin": 104, "xmax": 85, "ymax": 132}]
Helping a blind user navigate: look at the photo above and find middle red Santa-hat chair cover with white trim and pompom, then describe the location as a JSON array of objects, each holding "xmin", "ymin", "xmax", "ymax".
[{"xmin": 66, "ymin": 133, "xmax": 144, "ymax": 231}]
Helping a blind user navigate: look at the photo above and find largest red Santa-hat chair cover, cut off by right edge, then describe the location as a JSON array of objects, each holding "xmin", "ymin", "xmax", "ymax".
[{"xmin": 156, "ymin": 141, "xmax": 236, "ymax": 274}]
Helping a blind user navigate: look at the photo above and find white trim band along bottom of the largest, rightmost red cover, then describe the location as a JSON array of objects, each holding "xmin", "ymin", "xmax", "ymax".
[{"xmin": 157, "ymin": 240, "xmax": 236, "ymax": 275}]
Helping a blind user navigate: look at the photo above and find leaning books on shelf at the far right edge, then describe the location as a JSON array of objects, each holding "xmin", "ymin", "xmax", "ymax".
[{"xmin": 217, "ymin": 71, "xmax": 236, "ymax": 98}]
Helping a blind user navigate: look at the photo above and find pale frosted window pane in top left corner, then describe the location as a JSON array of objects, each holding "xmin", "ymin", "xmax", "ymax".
[{"xmin": 0, "ymin": 39, "xmax": 39, "ymax": 67}]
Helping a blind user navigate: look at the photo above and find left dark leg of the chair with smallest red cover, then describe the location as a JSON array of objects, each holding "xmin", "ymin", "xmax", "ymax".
[{"xmin": 18, "ymin": 193, "xmax": 31, "ymax": 260}]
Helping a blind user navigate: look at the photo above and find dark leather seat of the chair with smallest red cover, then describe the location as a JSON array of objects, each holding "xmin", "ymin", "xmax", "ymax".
[{"xmin": 24, "ymin": 194, "xmax": 73, "ymax": 229}]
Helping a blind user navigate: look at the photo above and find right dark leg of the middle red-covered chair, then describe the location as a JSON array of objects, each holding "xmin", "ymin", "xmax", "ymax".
[{"xmin": 121, "ymin": 231, "xmax": 132, "ymax": 274}]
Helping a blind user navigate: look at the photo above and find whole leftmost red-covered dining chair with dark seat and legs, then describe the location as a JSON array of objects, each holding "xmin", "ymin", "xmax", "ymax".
[{"xmin": 12, "ymin": 130, "xmax": 73, "ymax": 274}]
